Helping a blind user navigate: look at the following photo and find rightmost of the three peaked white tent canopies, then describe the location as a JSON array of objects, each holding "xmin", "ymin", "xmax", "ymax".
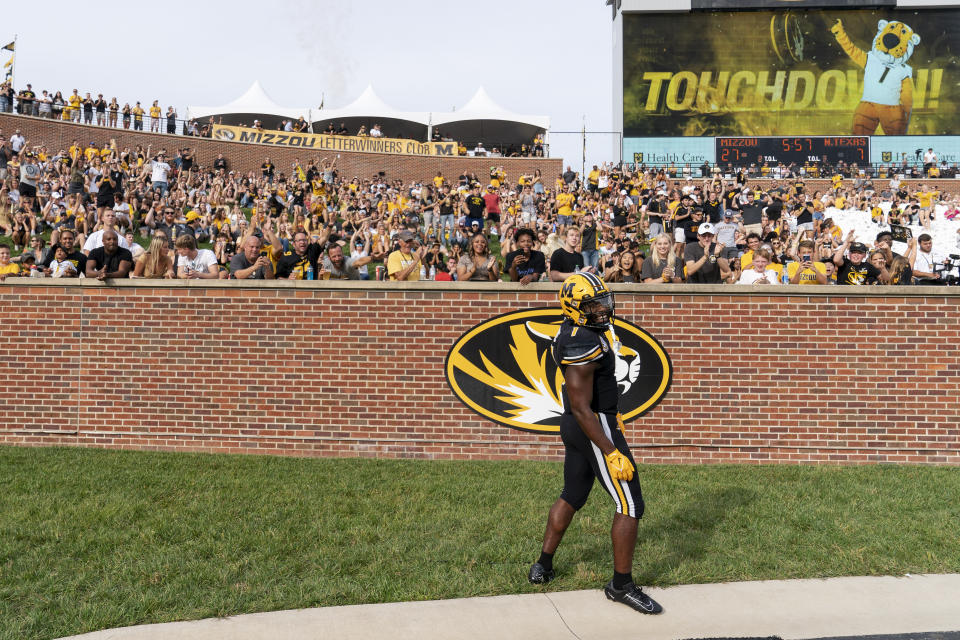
[{"xmin": 433, "ymin": 87, "xmax": 550, "ymax": 150}]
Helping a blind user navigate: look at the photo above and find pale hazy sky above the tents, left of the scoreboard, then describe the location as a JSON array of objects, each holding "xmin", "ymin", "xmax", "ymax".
[{"xmin": 0, "ymin": 0, "xmax": 614, "ymax": 170}]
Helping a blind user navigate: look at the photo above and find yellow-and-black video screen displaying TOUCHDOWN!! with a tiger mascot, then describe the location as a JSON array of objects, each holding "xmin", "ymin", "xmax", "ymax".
[{"xmin": 623, "ymin": 8, "xmax": 960, "ymax": 137}]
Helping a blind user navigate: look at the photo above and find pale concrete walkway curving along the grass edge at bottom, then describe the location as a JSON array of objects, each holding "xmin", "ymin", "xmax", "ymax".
[{"xmin": 62, "ymin": 574, "xmax": 960, "ymax": 640}]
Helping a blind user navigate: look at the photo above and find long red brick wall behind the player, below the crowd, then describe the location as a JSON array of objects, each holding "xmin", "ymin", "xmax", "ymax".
[{"xmin": 0, "ymin": 279, "xmax": 960, "ymax": 464}]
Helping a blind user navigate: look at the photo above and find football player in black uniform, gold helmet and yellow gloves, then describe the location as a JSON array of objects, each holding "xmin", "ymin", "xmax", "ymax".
[{"xmin": 527, "ymin": 272, "xmax": 663, "ymax": 613}]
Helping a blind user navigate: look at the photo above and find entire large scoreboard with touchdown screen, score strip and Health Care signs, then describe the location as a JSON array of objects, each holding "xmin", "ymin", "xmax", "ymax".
[{"xmin": 610, "ymin": 0, "xmax": 960, "ymax": 163}]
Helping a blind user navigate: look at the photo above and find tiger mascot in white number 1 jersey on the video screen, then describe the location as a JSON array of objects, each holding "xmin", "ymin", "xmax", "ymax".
[{"xmin": 830, "ymin": 19, "xmax": 920, "ymax": 136}]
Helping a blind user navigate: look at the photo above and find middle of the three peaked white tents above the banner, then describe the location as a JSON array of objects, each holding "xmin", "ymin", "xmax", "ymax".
[{"xmin": 313, "ymin": 85, "xmax": 430, "ymax": 140}]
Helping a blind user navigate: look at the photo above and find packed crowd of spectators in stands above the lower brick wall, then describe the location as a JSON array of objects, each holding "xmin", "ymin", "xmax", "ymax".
[{"xmin": 0, "ymin": 121, "xmax": 960, "ymax": 285}]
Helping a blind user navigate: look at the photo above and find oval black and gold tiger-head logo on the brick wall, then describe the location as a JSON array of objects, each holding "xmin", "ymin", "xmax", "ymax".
[{"xmin": 444, "ymin": 308, "xmax": 673, "ymax": 433}]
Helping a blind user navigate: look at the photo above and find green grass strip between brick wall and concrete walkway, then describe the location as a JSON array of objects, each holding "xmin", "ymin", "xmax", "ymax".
[{"xmin": 0, "ymin": 447, "xmax": 960, "ymax": 640}]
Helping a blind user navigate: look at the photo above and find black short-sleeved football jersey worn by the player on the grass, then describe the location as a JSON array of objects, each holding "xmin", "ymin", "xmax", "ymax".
[{"xmin": 551, "ymin": 320, "xmax": 620, "ymax": 415}]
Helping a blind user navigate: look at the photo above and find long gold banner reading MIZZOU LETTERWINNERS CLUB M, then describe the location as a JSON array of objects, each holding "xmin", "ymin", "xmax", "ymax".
[{"xmin": 213, "ymin": 124, "xmax": 457, "ymax": 156}]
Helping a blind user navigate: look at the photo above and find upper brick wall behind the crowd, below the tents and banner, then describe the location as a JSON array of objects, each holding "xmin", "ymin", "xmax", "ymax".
[{"xmin": 0, "ymin": 114, "xmax": 563, "ymax": 182}]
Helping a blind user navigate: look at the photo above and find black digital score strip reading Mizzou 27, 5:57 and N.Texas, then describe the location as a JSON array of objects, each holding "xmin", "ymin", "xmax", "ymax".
[{"xmin": 714, "ymin": 136, "xmax": 870, "ymax": 165}]
